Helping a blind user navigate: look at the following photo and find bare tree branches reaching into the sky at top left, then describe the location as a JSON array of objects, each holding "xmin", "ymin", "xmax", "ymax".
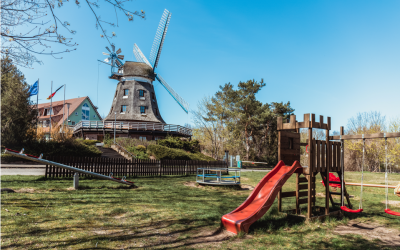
[{"xmin": 1, "ymin": 0, "xmax": 145, "ymax": 67}]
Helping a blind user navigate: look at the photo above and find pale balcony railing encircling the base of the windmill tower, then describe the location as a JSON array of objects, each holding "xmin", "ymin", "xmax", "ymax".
[{"xmin": 74, "ymin": 121, "xmax": 192, "ymax": 136}]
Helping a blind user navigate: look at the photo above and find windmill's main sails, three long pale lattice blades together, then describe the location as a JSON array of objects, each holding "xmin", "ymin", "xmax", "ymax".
[{"xmin": 133, "ymin": 9, "xmax": 189, "ymax": 113}]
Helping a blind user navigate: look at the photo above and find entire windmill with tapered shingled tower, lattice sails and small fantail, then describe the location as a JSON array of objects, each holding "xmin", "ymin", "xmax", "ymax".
[{"xmin": 104, "ymin": 10, "xmax": 189, "ymax": 127}]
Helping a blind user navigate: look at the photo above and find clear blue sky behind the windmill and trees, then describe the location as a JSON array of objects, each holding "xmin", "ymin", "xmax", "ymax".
[{"xmin": 22, "ymin": 0, "xmax": 400, "ymax": 133}]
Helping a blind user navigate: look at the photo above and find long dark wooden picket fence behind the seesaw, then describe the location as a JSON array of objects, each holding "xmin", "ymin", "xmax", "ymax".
[{"xmin": 45, "ymin": 156, "xmax": 227, "ymax": 178}]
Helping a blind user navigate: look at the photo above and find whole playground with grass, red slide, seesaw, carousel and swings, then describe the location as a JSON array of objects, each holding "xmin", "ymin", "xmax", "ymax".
[{"xmin": 1, "ymin": 114, "xmax": 400, "ymax": 249}]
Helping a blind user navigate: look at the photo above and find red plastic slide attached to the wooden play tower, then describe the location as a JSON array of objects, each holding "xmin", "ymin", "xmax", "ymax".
[{"xmin": 221, "ymin": 161, "xmax": 302, "ymax": 234}]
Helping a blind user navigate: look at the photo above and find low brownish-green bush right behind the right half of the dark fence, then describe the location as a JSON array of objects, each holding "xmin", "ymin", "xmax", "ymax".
[{"xmin": 147, "ymin": 145, "xmax": 214, "ymax": 161}]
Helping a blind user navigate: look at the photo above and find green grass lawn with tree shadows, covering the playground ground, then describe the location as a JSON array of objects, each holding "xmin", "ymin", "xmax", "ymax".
[{"xmin": 1, "ymin": 172, "xmax": 400, "ymax": 250}]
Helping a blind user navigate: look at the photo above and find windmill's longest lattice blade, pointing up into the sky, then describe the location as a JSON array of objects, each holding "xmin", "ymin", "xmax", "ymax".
[{"xmin": 150, "ymin": 9, "xmax": 171, "ymax": 68}]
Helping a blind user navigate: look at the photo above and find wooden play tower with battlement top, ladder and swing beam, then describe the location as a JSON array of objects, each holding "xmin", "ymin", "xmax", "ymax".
[{"xmin": 277, "ymin": 114, "xmax": 400, "ymax": 219}]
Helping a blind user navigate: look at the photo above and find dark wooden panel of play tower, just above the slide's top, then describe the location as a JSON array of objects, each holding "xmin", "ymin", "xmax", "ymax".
[{"xmin": 278, "ymin": 131, "xmax": 300, "ymax": 166}]
